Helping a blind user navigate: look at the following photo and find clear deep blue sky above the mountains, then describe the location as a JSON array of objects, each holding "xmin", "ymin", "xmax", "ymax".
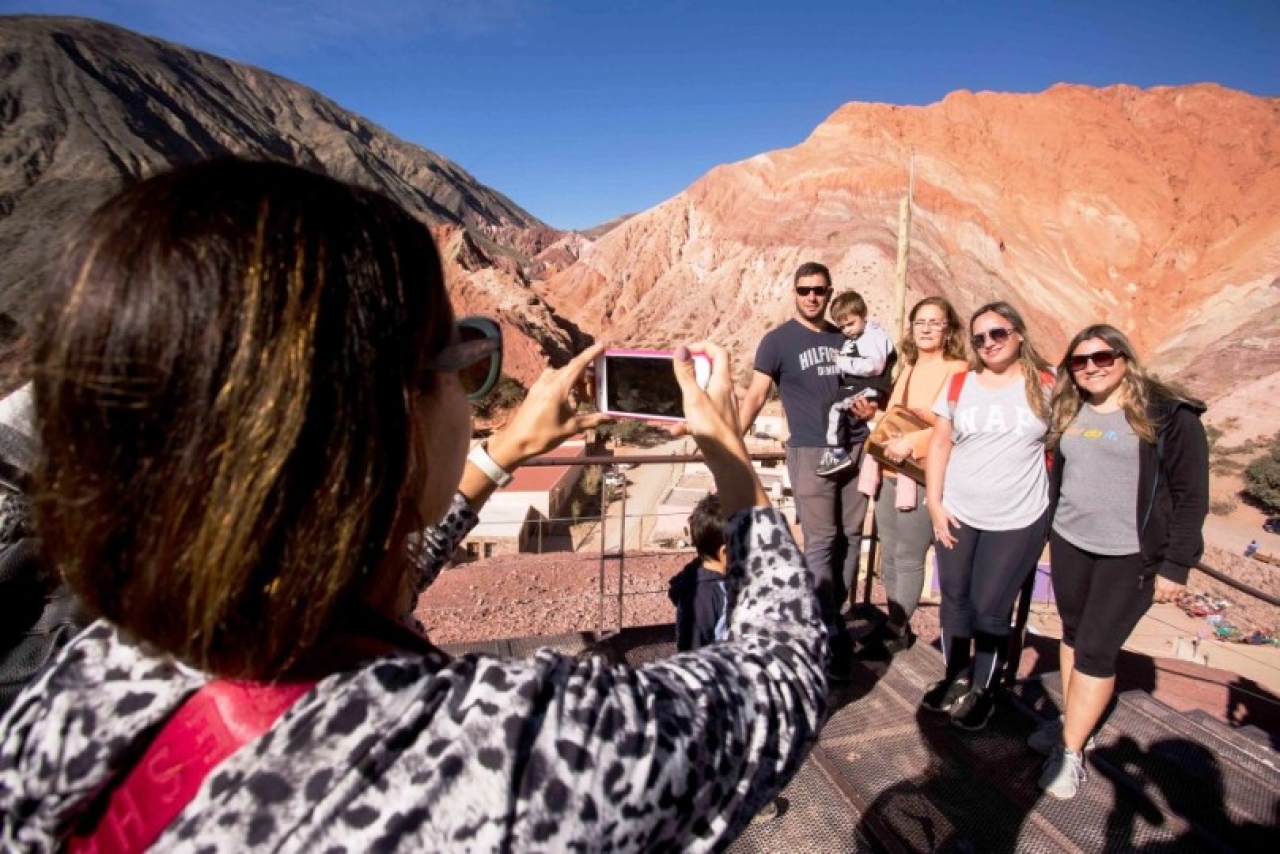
[{"xmin": 0, "ymin": 0, "xmax": 1280, "ymax": 228}]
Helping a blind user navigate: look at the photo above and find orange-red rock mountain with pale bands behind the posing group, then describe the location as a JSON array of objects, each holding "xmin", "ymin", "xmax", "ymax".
[{"xmin": 539, "ymin": 85, "xmax": 1280, "ymax": 419}]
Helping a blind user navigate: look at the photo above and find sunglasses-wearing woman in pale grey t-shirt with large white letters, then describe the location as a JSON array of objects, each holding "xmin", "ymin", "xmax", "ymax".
[{"xmin": 922, "ymin": 302, "xmax": 1053, "ymax": 730}]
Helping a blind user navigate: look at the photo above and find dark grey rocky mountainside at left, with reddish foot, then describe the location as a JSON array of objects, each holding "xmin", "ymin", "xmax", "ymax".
[{"xmin": 0, "ymin": 17, "xmax": 577, "ymax": 380}]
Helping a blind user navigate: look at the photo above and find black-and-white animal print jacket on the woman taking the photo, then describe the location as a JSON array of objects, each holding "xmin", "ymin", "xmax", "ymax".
[{"xmin": 0, "ymin": 495, "xmax": 827, "ymax": 854}]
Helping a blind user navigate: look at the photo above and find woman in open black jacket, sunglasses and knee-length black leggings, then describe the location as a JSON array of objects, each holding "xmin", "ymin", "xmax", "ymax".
[{"xmin": 1028, "ymin": 324, "xmax": 1208, "ymax": 799}]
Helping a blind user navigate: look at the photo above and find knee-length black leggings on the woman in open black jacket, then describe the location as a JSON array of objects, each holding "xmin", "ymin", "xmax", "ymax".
[{"xmin": 1048, "ymin": 531, "xmax": 1156, "ymax": 679}]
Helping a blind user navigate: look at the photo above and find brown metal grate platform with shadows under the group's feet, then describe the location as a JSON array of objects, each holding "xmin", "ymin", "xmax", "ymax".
[{"xmin": 449, "ymin": 615, "xmax": 1280, "ymax": 853}]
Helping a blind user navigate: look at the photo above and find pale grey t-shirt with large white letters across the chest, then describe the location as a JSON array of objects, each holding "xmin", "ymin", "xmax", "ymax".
[{"xmin": 933, "ymin": 371, "xmax": 1048, "ymax": 531}]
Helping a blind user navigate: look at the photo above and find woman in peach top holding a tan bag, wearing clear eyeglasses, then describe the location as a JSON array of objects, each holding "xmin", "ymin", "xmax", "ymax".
[{"xmin": 876, "ymin": 297, "xmax": 968, "ymax": 654}]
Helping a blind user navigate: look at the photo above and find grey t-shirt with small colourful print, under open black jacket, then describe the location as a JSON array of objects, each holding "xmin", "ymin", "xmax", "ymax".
[{"xmin": 1053, "ymin": 405, "xmax": 1138, "ymax": 554}]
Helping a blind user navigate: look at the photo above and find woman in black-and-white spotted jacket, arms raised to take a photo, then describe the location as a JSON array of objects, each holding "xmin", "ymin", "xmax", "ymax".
[{"xmin": 0, "ymin": 159, "xmax": 826, "ymax": 853}]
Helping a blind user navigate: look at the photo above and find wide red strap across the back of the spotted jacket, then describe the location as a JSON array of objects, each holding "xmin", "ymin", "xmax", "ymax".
[{"xmin": 65, "ymin": 679, "xmax": 315, "ymax": 854}]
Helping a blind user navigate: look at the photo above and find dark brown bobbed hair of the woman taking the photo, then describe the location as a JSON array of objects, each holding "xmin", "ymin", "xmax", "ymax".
[{"xmin": 33, "ymin": 159, "xmax": 453, "ymax": 679}]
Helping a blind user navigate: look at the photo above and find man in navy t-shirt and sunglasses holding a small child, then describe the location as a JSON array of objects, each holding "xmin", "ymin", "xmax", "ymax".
[{"xmin": 739, "ymin": 261, "xmax": 876, "ymax": 679}]
